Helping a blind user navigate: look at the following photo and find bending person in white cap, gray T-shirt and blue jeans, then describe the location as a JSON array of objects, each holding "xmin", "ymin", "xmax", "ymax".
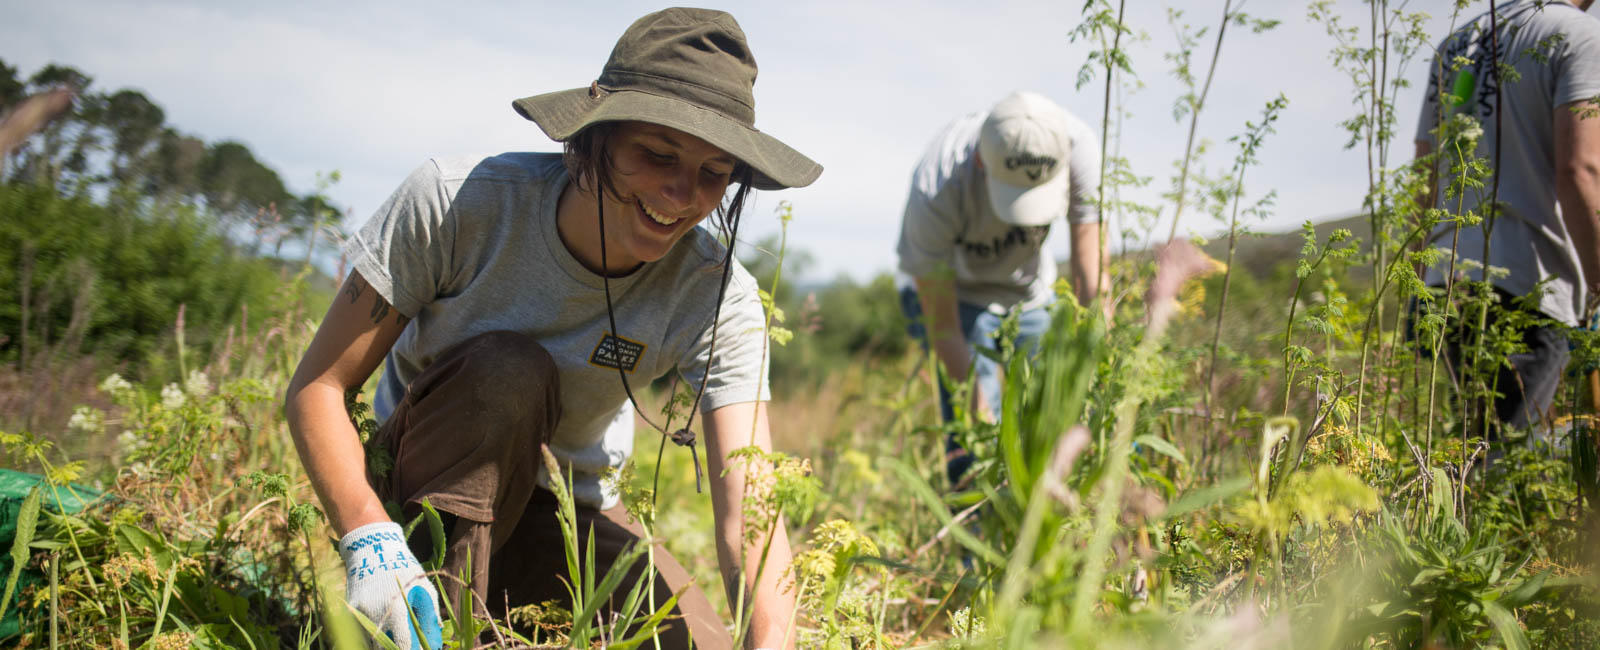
[{"xmin": 898, "ymin": 91, "xmax": 1102, "ymax": 485}]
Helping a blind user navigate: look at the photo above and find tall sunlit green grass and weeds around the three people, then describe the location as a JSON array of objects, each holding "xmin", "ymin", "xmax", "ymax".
[{"xmin": 0, "ymin": 0, "xmax": 1600, "ymax": 648}]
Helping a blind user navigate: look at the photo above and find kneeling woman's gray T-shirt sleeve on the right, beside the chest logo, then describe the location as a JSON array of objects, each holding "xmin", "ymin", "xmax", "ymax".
[{"xmin": 678, "ymin": 263, "xmax": 773, "ymax": 411}]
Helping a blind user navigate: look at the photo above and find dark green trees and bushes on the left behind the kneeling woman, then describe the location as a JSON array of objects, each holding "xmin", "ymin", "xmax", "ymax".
[{"xmin": 0, "ymin": 59, "xmax": 328, "ymax": 381}]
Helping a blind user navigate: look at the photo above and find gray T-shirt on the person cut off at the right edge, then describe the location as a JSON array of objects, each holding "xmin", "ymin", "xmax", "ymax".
[{"xmin": 1416, "ymin": 0, "xmax": 1600, "ymax": 325}]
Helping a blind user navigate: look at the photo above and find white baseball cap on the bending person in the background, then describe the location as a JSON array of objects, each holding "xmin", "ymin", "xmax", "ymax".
[{"xmin": 978, "ymin": 91, "xmax": 1072, "ymax": 226}]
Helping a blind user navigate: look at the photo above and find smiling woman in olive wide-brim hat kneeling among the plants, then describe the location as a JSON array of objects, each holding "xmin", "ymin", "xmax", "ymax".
[{"xmin": 285, "ymin": 8, "xmax": 822, "ymax": 647}]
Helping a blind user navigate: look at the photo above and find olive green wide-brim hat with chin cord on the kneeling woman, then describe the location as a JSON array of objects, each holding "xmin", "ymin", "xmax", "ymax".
[{"xmin": 512, "ymin": 6, "xmax": 822, "ymax": 189}]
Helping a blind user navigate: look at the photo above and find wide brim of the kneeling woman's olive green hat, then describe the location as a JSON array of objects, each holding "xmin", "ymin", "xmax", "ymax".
[{"xmin": 512, "ymin": 88, "xmax": 822, "ymax": 189}]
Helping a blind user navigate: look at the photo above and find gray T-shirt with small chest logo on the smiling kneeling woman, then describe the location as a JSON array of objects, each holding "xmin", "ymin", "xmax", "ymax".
[{"xmin": 346, "ymin": 154, "xmax": 768, "ymax": 508}]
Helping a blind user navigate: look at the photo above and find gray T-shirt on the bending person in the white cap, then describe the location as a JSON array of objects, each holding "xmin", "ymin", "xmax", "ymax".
[{"xmin": 898, "ymin": 112, "xmax": 1101, "ymax": 309}]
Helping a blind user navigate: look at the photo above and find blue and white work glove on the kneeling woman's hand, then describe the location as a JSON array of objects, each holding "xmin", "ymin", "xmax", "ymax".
[{"xmin": 339, "ymin": 522, "xmax": 445, "ymax": 650}]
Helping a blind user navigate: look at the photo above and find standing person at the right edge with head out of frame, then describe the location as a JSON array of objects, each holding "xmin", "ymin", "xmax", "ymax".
[{"xmin": 1416, "ymin": 0, "xmax": 1600, "ymax": 435}]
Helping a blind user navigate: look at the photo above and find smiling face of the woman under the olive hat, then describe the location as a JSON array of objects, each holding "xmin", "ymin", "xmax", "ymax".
[{"xmin": 557, "ymin": 122, "xmax": 738, "ymax": 274}]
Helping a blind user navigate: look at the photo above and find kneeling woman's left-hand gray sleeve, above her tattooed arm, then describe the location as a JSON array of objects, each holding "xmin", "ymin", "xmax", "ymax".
[{"xmin": 344, "ymin": 162, "xmax": 454, "ymax": 317}]
